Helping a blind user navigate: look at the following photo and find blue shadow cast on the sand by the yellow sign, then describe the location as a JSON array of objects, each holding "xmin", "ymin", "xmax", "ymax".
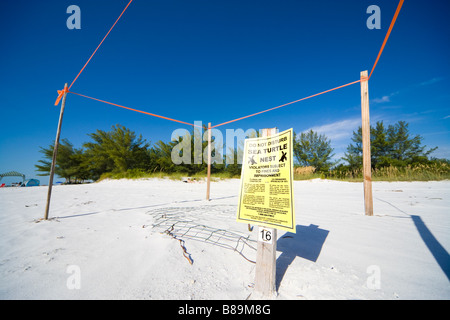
[{"xmin": 276, "ymin": 224, "xmax": 330, "ymax": 290}]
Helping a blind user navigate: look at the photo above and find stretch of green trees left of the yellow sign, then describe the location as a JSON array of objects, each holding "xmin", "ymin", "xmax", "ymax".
[{"xmin": 35, "ymin": 124, "xmax": 225, "ymax": 183}]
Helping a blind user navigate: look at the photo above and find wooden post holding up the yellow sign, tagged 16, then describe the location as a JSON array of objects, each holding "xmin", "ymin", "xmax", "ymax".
[{"xmin": 255, "ymin": 128, "xmax": 277, "ymax": 298}]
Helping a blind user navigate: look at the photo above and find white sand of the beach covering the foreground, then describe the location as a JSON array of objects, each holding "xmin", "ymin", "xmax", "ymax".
[{"xmin": 0, "ymin": 179, "xmax": 450, "ymax": 299}]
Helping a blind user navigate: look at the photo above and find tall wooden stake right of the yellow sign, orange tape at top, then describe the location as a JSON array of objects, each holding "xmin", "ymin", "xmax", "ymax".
[{"xmin": 361, "ymin": 71, "xmax": 373, "ymax": 216}]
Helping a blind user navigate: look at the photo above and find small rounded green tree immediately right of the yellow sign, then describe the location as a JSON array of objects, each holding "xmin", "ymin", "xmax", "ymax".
[{"xmin": 294, "ymin": 130, "xmax": 334, "ymax": 171}]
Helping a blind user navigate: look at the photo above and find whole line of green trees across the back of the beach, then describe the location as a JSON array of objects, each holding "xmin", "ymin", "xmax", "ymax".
[{"xmin": 35, "ymin": 121, "xmax": 442, "ymax": 183}]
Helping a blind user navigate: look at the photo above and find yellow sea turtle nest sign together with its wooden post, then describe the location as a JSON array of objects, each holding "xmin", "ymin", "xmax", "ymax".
[{"xmin": 237, "ymin": 128, "xmax": 295, "ymax": 298}]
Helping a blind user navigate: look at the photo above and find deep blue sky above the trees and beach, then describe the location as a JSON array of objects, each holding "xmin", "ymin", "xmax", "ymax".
[{"xmin": 0, "ymin": 0, "xmax": 450, "ymax": 182}]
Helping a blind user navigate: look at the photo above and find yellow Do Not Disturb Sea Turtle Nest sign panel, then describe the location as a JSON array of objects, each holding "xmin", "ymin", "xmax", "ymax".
[{"xmin": 237, "ymin": 129, "xmax": 295, "ymax": 233}]
